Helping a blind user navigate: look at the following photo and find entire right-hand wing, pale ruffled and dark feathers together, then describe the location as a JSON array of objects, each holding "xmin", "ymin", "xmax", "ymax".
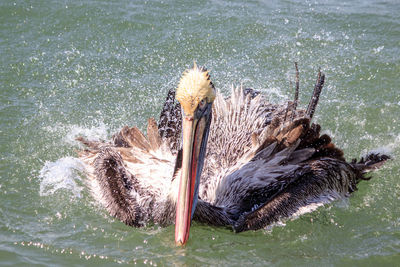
[{"xmin": 200, "ymin": 70, "xmax": 360, "ymax": 231}]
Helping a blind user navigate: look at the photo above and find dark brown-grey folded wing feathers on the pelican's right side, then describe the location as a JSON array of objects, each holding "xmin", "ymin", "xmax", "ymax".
[{"xmin": 223, "ymin": 118, "xmax": 359, "ymax": 226}]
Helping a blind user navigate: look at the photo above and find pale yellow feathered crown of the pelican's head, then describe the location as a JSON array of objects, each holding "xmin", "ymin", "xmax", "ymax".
[{"xmin": 176, "ymin": 64, "xmax": 215, "ymax": 116}]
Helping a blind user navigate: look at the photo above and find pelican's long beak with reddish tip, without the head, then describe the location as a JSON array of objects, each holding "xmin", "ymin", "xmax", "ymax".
[{"xmin": 175, "ymin": 116, "xmax": 207, "ymax": 245}]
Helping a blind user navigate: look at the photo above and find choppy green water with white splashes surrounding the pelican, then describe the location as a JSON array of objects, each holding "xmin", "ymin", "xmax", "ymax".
[{"xmin": 0, "ymin": 0, "xmax": 400, "ymax": 266}]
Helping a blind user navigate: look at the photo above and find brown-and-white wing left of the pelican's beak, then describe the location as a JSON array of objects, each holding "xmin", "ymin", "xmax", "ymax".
[{"xmin": 79, "ymin": 119, "xmax": 176, "ymax": 226}]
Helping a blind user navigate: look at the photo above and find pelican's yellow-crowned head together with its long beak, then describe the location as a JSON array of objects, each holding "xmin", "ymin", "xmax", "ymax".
[{"xmin": 175, "ymin": 64, "xmax": 215, "ymax": 245}]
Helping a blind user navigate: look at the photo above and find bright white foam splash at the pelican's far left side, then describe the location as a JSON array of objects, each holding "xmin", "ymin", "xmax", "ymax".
[{"xmin": 39, "ymin": 157, "xmax": 84, "ymax": 197}]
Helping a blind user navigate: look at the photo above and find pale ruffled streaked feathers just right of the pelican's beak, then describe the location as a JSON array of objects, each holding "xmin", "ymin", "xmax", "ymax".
[{"xmin": 199, "ymin": 87, "xmax": 305, "ymax": 204}]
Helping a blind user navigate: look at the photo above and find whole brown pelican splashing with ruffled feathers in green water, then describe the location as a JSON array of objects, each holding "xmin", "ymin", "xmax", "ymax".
[{"xmin": 79, "ymin": 65, "xmax": 388, "ymax": 245}]
